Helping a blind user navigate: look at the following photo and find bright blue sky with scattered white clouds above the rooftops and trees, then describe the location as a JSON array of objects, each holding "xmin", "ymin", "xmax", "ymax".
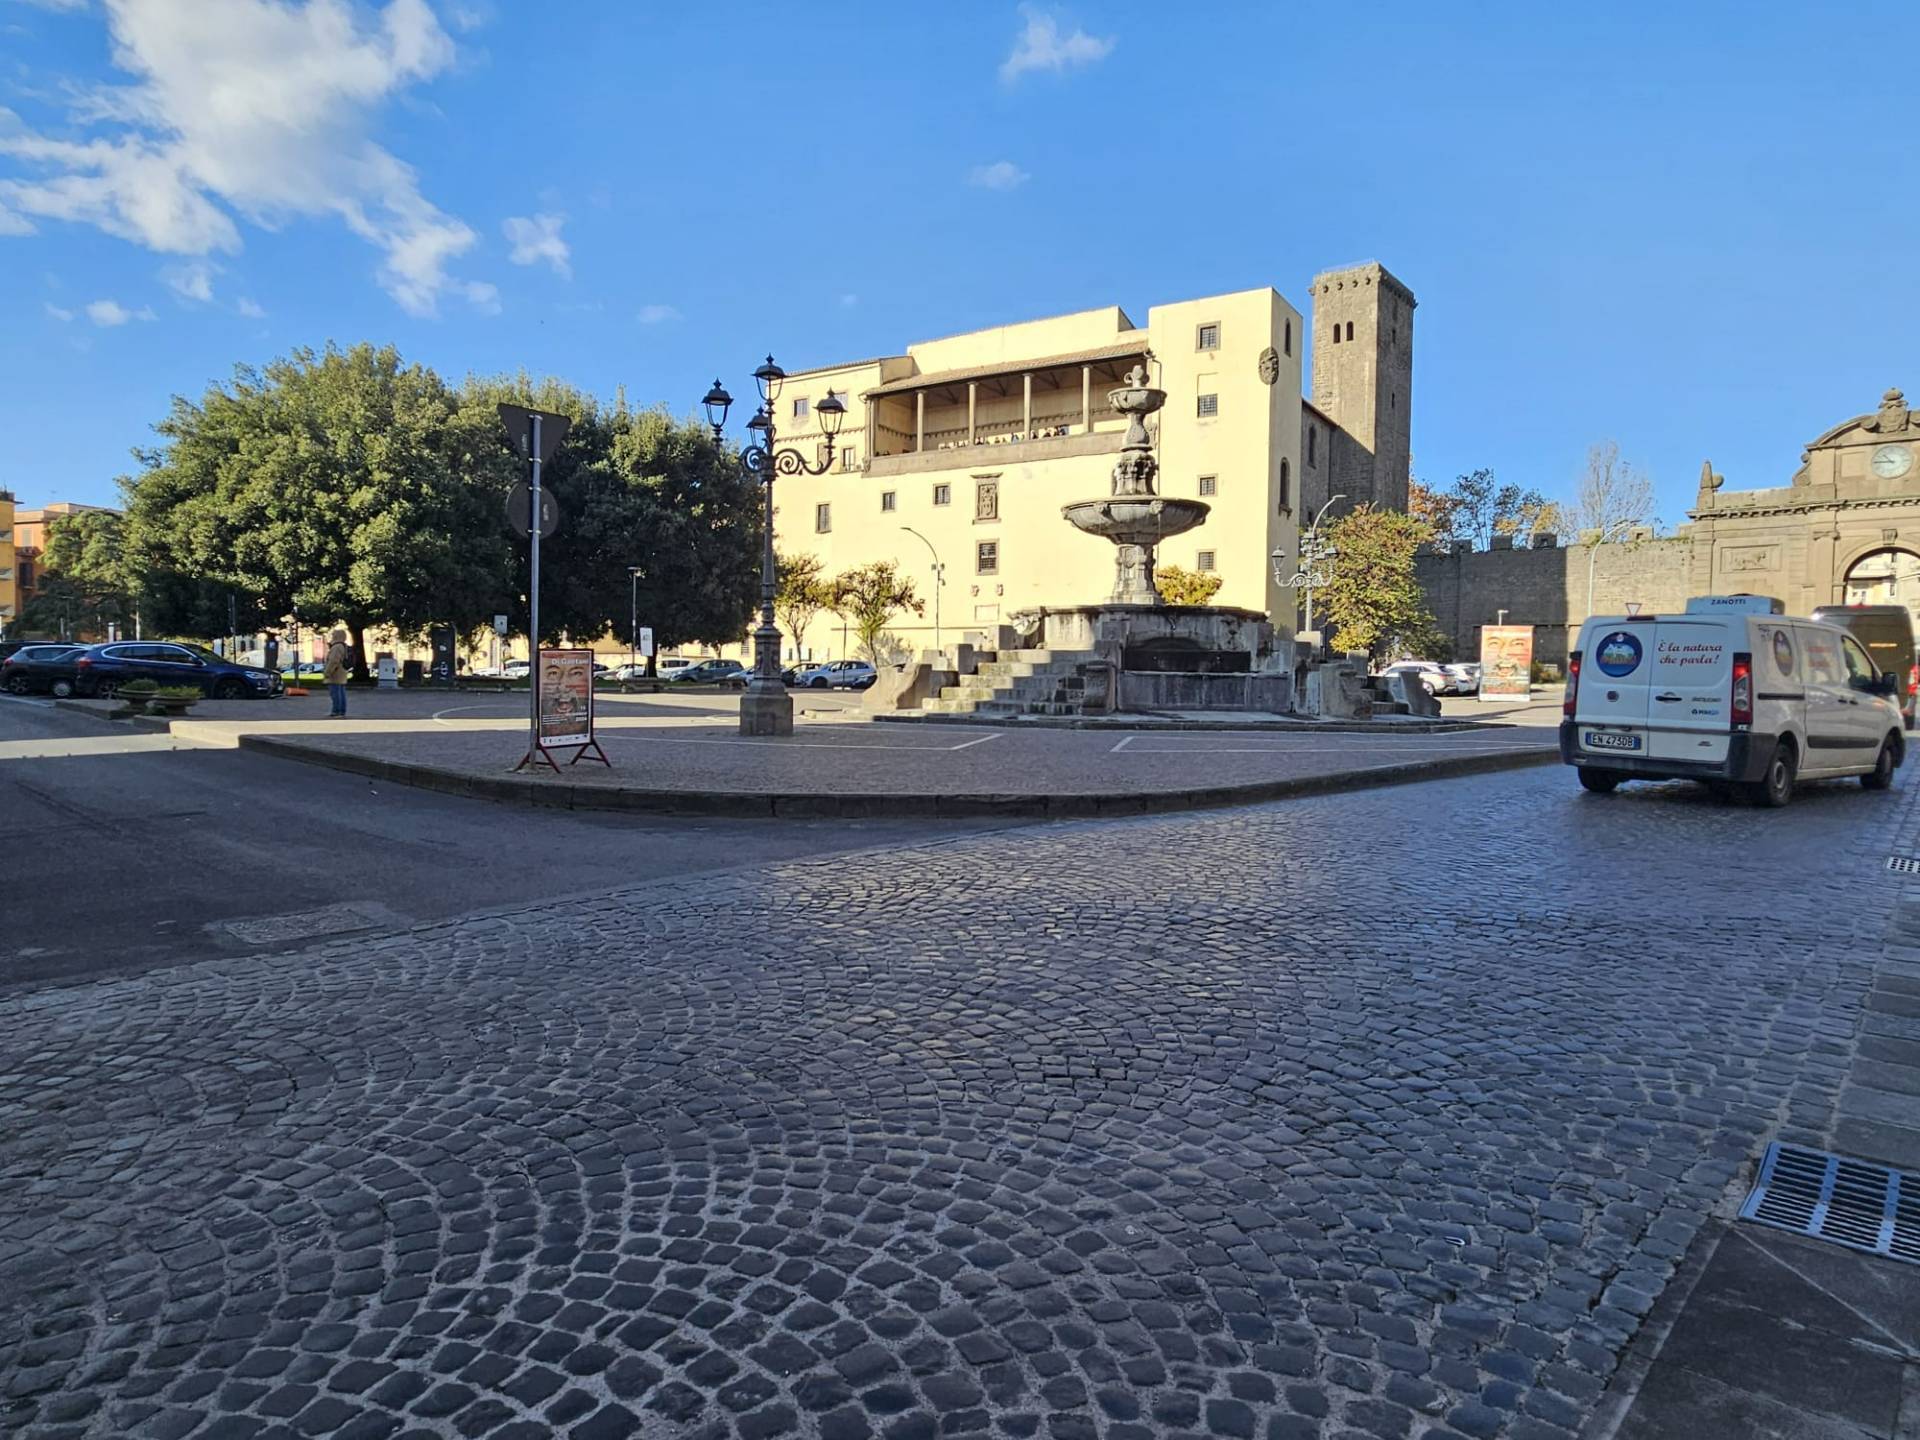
[{"xmin": 0, "ymin": 0, "xmax": 1920, "ymax": 522}]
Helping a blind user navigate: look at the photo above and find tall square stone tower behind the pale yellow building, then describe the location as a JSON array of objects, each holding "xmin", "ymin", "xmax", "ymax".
[{"xmin": 1313, "ymin": 261, "xmax": 1415, "ymax": 511}]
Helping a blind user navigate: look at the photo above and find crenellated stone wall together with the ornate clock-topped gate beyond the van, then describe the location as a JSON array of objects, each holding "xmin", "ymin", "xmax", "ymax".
[{"xmin": 1417, "ymin": 390, "xmax": 1920, "ymax": 660}]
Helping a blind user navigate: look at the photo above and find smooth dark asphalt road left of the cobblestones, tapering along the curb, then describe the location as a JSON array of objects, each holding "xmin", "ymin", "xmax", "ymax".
[{"xmin": 0, "ymin": 697, "xmax": 1006, "ymax": 991}]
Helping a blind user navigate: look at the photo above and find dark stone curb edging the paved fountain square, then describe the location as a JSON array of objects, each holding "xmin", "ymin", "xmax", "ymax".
[{"xmin": 240, "ymin": 735, "xmax": 1559, "ymax": 820}]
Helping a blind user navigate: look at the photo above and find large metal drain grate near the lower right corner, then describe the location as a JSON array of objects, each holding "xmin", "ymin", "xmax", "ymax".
[{"xmin": 1740, "ymin": 1140, "xmax": 1920, "ymax": 1265}]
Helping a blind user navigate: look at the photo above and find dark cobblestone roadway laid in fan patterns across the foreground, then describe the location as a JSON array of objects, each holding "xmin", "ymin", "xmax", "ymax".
[{"xmin": 0, "ymin": 768, "xmax": 1910, "ymax": 1440}]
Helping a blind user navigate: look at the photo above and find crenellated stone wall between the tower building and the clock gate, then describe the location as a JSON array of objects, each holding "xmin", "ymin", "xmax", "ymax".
[{"xmin": 1413, "ymin": 536, "xmax": 1701, "ymax": 664}]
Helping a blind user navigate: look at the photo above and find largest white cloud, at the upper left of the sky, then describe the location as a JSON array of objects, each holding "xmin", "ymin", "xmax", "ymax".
[{"xmin": 0, "ymin": 0, "xmax": 487, "ymax": 315}]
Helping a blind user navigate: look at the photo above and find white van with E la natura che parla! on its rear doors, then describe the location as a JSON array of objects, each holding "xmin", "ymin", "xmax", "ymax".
[{"xmin": 1559, "ymin": 595, "xmax": 1907, "ymax": 804}]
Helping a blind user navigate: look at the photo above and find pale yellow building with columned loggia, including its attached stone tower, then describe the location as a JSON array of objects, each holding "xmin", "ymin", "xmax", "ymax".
[{"xmin": 774, "ymin": 263, "xmax": 1413, "ymax": 660}]
